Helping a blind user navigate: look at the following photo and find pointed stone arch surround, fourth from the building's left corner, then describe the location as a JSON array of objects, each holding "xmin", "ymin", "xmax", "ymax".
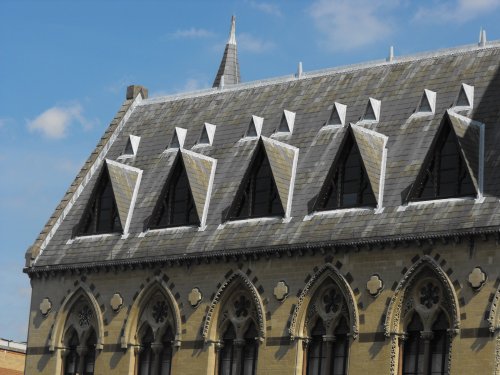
[{"xmin": 289, "ymin": 263, "xmax": 359, "ymax": 340}]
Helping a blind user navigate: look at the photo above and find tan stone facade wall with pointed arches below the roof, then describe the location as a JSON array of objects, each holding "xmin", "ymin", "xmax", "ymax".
[{"xmin": 26, "ymin": 242, "xmax": 500, "ymax": 375}]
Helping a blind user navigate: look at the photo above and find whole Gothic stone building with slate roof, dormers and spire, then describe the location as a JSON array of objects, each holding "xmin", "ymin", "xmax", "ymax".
[{"xmin": 25, "ymin": 20, "xmax": 500, "ymax": 375}]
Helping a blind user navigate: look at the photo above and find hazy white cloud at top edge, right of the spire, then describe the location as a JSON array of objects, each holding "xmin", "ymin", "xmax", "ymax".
[{"xmin": 310, "ymin": 0, "xmax": 397, "ymax": 50}]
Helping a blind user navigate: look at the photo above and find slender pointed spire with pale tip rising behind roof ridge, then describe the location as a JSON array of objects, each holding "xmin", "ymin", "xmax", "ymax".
[{"xmin": 212, "ymin": 16, "xmax": 240, "ymax": 87}]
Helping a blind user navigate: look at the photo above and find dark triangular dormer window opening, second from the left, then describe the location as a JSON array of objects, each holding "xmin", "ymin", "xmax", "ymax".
[{"xmin": 149, "ymin": 153, "xmax": 200, "ymax": 229}]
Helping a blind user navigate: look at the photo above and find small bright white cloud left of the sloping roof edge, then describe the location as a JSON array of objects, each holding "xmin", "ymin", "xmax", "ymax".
[{"xmin": 27, "ymin": 103, "xmax": 95, "ymax": 139}]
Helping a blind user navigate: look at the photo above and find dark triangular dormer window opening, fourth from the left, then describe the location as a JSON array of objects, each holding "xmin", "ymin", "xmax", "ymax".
[{"xmin": 315, "ymin": 129, "xmax": 377, "ymax": 211}]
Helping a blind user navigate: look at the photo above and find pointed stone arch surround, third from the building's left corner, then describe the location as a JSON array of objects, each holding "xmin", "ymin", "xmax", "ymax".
[{"xmin": 203, "ymin": 270, "xmax": 266, "ymax": 342}]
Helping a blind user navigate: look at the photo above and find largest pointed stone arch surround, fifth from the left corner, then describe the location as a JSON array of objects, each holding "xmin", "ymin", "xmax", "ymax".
[{"xmin": 384, "ymin": 255, "xmax": 460, "ymax": 337}]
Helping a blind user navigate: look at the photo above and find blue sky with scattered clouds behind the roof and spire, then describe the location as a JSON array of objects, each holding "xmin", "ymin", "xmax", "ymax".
[{"xmin": 0, "ymin": 0, "xmax": 500, "ymax": 341}]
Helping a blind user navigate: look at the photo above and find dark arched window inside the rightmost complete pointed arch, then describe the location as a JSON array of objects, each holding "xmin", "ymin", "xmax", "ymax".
[{"xmin": 402, "ymin": 279, "xmax": 450, "ymax": 375}]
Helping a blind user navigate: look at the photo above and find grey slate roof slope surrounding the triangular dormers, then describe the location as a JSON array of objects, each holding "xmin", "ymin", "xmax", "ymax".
[{"xmin": 27, "ymin": 43, "xmax": 500, "ymax": 272}]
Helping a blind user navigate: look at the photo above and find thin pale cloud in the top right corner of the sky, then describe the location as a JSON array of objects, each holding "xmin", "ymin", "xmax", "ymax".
[{"xmin": 414, "ymin": 0, "xmax": 500, "ymax": 23}]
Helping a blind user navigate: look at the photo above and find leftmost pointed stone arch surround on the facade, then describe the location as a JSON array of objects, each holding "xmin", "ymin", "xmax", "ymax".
[{"xmin": 49, "ymin": 285, "xmax": 104, "ymax": 351}]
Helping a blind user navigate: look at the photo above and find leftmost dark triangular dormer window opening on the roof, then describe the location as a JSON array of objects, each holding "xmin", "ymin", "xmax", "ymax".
[{"xmin": 77, "ymin": 165, "xmax": 123, "ymax": 236}]
